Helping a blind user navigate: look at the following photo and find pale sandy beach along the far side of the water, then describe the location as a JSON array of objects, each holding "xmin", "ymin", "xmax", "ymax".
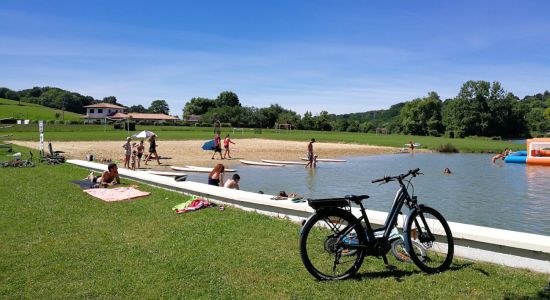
[{"xmin": 14, "ymin": 139, "xmax": 422, "ymax": 170}]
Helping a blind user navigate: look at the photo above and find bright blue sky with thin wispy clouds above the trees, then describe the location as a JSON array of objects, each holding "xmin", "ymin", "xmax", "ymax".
[{"xmin": 0, "ymin": 0, "xmax": 550, "ymax": 115}]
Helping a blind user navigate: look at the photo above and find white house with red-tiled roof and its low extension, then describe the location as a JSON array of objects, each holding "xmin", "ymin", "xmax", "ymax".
[{"xmin": 83, "ymin": 103, "xmax": 179, "ymax": 123}]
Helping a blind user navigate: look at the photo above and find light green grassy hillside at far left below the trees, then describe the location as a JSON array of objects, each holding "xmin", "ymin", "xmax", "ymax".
[{"xmin": 0, "ymin": 98, "xmax": 81, "ymax": 121}]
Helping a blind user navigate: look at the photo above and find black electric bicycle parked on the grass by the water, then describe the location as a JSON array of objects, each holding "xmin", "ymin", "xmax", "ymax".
[{"xmin": 300, "ymin": 169, "xmax": 454, "ymax": 280}]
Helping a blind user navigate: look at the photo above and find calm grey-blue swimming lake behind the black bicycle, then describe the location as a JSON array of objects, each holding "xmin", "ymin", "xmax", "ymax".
[{"xmin": 189, "ymin": 154, "xmax": 550, "ymax": 235}]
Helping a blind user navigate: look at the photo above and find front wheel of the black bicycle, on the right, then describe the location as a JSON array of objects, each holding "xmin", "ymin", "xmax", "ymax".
[{"xmin": 404, "ymin": 206, "xmax": 454, "ymax": 274}]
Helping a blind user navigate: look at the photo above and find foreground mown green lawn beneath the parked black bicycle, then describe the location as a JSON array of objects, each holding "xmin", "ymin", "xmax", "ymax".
[{"xmin": 0, "ymin": 148, "xmax": 549, "ymax": 299}]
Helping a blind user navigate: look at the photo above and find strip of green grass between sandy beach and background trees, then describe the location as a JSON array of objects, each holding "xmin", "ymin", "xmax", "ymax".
[{"xmin": 2, "ymin": 124, "xmax": 525, "ymax": 153}]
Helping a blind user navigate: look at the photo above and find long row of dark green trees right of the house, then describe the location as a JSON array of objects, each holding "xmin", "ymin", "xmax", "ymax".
[{"xmin": 187, "ymin": 81, "xmax": 550, "ymax": 137}]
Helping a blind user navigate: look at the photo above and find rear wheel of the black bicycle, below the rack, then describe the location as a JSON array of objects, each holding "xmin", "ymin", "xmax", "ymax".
[{"xmin": 300, "ymin": 209, "xmax": 367, "ymax": 280}]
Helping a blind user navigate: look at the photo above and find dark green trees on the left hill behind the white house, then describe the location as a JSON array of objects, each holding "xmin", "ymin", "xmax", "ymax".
[{"xmin": 0, "ymin": 87, "xmax": 170, "ymax": 114}]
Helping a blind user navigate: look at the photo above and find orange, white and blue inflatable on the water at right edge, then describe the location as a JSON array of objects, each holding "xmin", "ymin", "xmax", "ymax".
[{"xmin": 504, "ymin": 138, "xmax": 550, "ymax": 166}]
